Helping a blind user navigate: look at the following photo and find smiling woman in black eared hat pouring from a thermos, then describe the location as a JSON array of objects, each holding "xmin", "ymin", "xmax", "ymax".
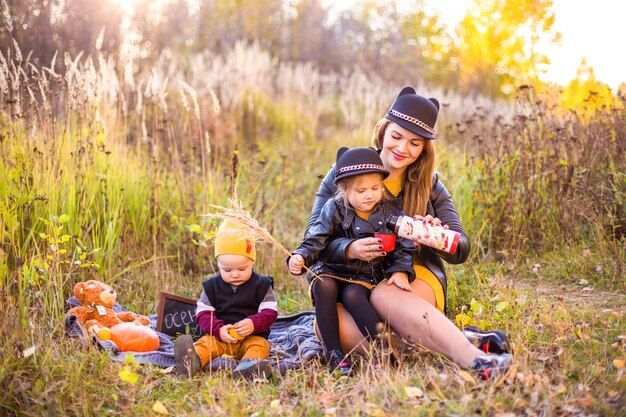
[{"xmin": 307, "ymin": 87, "xmax": 511, "ymax": 376}]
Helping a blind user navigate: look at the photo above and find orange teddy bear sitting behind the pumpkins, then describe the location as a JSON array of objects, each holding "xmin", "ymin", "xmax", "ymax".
[{"xmin": 66, "ymin": 280, "xmax": 150, "ymax": 335}]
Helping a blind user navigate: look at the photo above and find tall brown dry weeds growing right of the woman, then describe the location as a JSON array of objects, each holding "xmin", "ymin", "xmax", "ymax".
[{"xmin": 450, "ymin": 88, "xmax": 626, "ymax": 289}]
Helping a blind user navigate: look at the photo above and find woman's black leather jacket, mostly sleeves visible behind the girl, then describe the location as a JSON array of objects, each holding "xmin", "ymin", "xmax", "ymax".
[{"xmin": 305, "ymin": 167, "xmax": 470, "ymax": 308}]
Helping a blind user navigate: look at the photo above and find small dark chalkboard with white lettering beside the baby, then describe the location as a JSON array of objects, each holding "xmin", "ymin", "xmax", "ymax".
[{"xmin": 157, "ymin": 292, "xmax": 204, "ymax": 338}]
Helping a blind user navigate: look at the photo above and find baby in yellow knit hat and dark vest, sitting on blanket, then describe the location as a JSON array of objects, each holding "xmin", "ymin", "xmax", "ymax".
[{"xmin": 174, "ymin": 222, "xmax": 278, "ymax": 379}]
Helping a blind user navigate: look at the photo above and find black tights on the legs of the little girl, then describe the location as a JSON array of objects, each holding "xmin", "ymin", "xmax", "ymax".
[{"xmin": 313, "ymin": 277, "xmax": 380, "ymax": 351}]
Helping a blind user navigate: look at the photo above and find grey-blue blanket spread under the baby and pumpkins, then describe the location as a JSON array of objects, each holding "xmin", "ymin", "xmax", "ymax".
[{"xmin": 65, "ymin": 297, "xmax": 324, "ymax": 374}]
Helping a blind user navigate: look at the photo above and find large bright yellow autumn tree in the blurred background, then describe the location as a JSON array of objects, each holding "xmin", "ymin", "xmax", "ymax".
[{"xmin": 452, "ymin": 0, "xmax": 560, "ymax": 97}]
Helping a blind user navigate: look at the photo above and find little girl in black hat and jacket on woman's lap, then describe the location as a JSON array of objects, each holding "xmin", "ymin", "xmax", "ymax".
[{"xmin": 288, "ymin": 148, "xmax": 415, "ymax": 375}]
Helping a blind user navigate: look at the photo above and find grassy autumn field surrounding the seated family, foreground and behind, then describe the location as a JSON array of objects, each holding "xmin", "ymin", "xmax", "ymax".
[{"xmin": 0, "ymin": 42, "xmax": 626, "ymax": 416}]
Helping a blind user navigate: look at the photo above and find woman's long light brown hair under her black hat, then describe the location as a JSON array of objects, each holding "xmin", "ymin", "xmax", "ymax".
[{"xmin": 372, "ymin": 118, "xmax": 435, "ymax": 216}]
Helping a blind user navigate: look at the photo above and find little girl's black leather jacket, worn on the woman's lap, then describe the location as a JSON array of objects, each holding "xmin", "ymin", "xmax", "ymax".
[{"xmin": 293, "ymin": 198, "xmax": 416, "ymax": 286}]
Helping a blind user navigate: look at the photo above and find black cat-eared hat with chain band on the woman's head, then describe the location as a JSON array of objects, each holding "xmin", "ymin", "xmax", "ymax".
[{"xmin": 385, "ymin": 87, "xmax": 439, "ymax": 139}]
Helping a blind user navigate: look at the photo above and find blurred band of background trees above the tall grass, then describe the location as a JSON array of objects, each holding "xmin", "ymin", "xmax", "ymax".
[{"xmin": 0, "ymin": 0, "xmax": 584, "ymax": 97}]
